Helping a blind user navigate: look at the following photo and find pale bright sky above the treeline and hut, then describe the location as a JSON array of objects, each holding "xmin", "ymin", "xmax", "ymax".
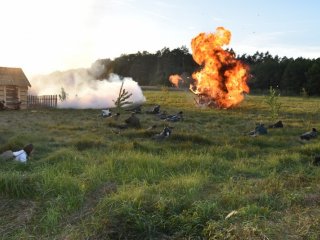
[{"xmin": 0, "ymin": 0, "xmax": 320, "ymax": 77}]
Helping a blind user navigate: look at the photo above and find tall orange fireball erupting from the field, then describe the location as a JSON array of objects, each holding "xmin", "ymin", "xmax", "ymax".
[{"xmin": 190, "ymin": 27, "xmax": 249, "ymax": 108}]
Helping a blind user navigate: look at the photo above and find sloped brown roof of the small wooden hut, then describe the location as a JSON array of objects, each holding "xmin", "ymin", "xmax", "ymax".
[{"xmin": 0, "ymin": 67, "xmax": 31, "ymax": 87}]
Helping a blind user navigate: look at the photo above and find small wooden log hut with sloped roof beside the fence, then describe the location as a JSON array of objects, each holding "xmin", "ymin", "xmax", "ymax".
[{"xmin": 0, "ymin": 67, "xmax": 31, "ymax": 109}]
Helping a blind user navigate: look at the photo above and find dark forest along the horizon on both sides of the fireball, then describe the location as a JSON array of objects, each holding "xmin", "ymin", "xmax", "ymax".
[{"xmin": 92, "ymin": 46, "xmax": 320, "ymax": 96}]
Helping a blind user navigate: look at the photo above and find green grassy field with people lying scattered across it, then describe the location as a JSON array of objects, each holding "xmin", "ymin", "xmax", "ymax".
[{"xmin": 0, "ymin": 89, "xmax": 320, "ymax": 240}]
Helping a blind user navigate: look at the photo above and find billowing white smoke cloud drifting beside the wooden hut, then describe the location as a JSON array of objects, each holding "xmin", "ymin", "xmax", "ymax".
[{"xmin": 29, "ymin": 65, "xmax": 146, "ymax": 109}]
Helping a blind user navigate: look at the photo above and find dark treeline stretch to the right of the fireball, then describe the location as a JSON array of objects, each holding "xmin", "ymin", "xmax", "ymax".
[{"xmin": 238, "ymin": 52, "xmax": 320, "ymax": 96}]
